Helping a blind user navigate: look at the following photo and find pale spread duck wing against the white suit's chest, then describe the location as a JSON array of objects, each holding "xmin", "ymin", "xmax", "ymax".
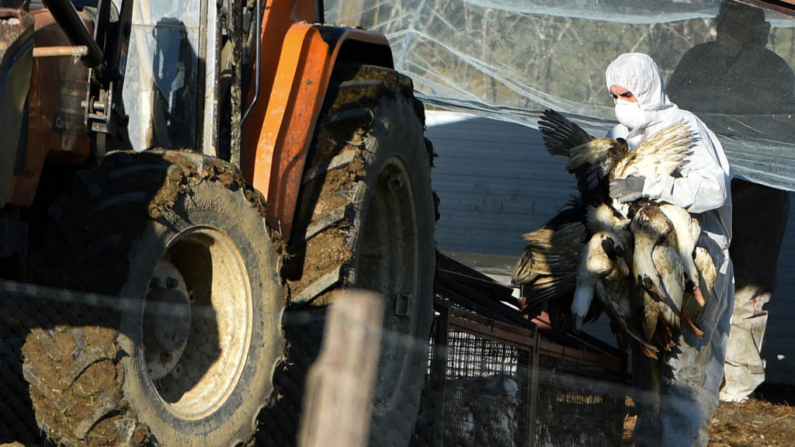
[{"xmin": 613, "ymin": 119, "xmax": 697, "ymax": 182}]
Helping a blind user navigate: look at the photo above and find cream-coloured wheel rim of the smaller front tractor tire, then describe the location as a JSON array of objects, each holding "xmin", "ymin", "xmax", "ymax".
[{"xmin": 142, "ymin": 228, "xmax": 253, "ymax": 419}]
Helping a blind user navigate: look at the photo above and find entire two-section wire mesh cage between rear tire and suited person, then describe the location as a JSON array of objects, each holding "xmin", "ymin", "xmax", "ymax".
[{"xmin": 413, "ymin": 290, "xmax": 626, "ymax": 447}]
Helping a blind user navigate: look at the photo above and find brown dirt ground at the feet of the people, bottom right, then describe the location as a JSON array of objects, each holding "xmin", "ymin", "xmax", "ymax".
[{"xmin": 621, "ymin": 393, "xmax": 795, "ymax": 447}]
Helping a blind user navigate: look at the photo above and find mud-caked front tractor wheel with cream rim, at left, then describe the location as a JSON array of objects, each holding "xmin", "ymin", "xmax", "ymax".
[{"xmin": 23, "ymin": 152, "xmax": 285, "ymax": 447}]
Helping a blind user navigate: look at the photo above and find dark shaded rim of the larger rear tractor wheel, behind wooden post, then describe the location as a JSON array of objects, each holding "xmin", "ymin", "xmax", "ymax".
[{"xmin": 359, "ymin": 158, "xmax": 419, "ymax": 415}]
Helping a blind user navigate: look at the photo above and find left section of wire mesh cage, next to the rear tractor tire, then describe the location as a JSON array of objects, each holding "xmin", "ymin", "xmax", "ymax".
[{"xmin": 412, "ymin": 308, "xmax": 535, "ymax": 447}]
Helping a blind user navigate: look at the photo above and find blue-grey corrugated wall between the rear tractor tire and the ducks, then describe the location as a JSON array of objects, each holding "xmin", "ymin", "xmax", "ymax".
[{"xmin": 427, "ymin": 112, "xmax": 575, "ymax": 256}]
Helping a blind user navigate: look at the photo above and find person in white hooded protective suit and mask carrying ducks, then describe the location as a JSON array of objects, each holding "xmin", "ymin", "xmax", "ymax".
[{"xmin": 605, "ymin": 53, "xmax": 734, "ymax": 447}]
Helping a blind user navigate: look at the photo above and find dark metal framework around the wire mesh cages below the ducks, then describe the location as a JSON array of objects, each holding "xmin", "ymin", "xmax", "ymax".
[{"xmin": 432, "ymin": 254, "xmax": 627, "ymax": 446}]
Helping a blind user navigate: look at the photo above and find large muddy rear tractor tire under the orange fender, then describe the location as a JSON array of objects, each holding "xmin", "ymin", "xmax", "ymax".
[{"xmin": 288, "ymin": 66, "xmax": 436, "ymax": 446}]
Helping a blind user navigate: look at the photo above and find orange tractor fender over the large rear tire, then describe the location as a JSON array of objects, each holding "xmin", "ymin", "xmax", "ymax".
[{"xmin": 243, "ymin": 22, "xmax": 393, "ymax": 240}]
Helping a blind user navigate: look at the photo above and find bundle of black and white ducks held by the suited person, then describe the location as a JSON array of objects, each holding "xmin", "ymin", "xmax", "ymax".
[{"xmin": 512, "ymin": 110, "xmax": 717, "ymax": 358}]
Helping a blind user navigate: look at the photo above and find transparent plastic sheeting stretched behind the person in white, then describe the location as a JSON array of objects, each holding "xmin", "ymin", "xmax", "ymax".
[{"xmin": 326, "ymin": 0, "xmax": 795, "ymax": 190}]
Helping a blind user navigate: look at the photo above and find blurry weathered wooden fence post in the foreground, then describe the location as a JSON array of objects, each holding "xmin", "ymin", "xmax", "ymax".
[{"xmin": 298, "ymin": 290, "xmax": 383, "ymax": 447}]
